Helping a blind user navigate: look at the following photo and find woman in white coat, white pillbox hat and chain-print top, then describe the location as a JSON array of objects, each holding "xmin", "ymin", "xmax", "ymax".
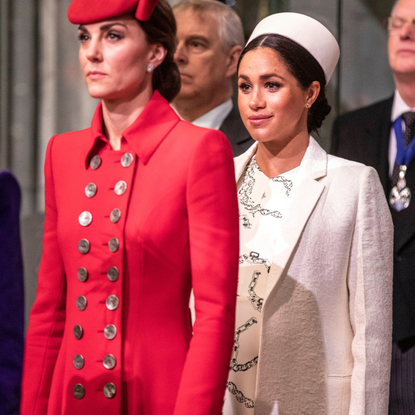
[{"xmin": 224, "ymin": 13, "xmax": 393, "ymax": 415}]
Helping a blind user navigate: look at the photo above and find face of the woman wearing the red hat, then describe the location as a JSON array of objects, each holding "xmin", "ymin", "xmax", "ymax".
[{"xmin": 78, "ymin": 15, "xmax": 165, "ymax": 101}]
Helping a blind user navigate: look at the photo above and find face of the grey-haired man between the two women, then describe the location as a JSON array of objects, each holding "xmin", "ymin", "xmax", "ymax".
[{"xmin": 174, "ymin": 10, "xmax": 233, "ymax": 101}]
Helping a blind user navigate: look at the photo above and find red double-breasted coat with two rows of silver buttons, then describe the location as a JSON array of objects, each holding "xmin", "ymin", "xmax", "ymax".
[{"xmin": 22, "ymin": 92, "xmax": 239, "ymax": 415}]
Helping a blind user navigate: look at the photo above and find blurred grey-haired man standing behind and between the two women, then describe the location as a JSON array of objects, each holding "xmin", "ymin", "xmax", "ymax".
[{"xmin": 173, "ymin": 0, "xmax": 253, "ymax": 156}]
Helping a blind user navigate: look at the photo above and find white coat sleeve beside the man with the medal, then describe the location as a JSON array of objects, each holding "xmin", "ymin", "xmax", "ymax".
[{"xmin": 348, "ymin": 167, "xmax": 393, "ymax": 415}]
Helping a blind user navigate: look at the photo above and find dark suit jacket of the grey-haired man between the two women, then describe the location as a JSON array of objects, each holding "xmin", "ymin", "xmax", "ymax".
[{"xmin": 219, "ymin": 107, "xmax": 254, "ymax": 157}]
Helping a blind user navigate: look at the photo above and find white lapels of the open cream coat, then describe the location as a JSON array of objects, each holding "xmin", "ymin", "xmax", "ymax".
[{"xmin": 235, "ymin": 137, "xmax": 328, "ymax": 304}]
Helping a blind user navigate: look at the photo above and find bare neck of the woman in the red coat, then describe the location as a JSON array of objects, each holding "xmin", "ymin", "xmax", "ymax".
[{"xmin": 102, "ymin": 89, "xmax": 153, "ymax": 150}]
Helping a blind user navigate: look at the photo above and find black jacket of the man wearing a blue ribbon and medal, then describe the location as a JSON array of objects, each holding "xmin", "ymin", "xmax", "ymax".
[{"xmin": 331, "ymin": 97, "xmax": 415, "ymax": 350}]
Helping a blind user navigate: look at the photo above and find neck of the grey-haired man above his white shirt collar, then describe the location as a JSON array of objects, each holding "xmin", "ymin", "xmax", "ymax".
[{"xmin": 173, "ymin": 86, "xmax": 233, "ymax": 122}]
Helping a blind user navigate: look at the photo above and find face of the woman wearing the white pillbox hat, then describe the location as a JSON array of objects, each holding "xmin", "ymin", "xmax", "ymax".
[{"xmin": 238, "ymin": 47, "xmax": 314, "ymax": 142}]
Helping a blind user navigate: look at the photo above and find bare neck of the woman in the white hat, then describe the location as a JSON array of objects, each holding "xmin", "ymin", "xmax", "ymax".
[{"xmin": 255, "ymin": 131, "xmax": 309, "ymax": 178}]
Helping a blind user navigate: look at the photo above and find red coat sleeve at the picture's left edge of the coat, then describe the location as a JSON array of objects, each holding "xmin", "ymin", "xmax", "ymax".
[{"xmin": 21, "ymin": 137, "xmax": 66, "ymax": 415}]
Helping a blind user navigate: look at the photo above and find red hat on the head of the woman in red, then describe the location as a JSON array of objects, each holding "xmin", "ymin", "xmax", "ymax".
[{"xmin": 68, "ymin": 0, "xmax": 158, "ymax": 24}]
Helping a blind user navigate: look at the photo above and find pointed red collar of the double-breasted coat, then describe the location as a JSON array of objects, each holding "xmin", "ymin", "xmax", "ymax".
[{"xmin": 85, "ymin": 91, "xmax": 180, "ymax": 168}]
